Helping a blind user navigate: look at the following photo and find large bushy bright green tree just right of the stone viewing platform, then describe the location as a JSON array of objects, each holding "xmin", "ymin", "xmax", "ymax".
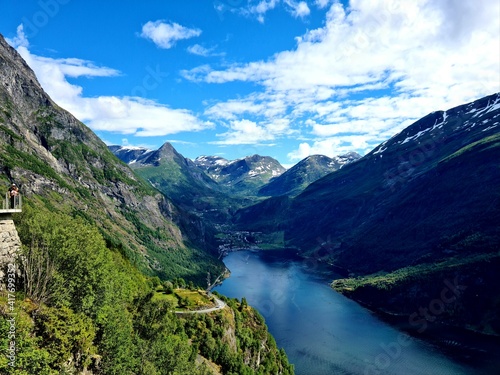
[{"xmin": 18, "ymin": 208, "xmax": 112, "ymax": 316}]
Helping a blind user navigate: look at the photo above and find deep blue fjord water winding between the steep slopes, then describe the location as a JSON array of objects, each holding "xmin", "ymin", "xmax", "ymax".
[{"xmin": 216, "ymin": 251, "xmax": 476, "ymax": 375}]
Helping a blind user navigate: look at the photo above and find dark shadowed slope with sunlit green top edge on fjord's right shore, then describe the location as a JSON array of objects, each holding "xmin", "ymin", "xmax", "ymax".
[{"xmin": 332, "ymin": 253, "xmax": 500, "ymax": 336}]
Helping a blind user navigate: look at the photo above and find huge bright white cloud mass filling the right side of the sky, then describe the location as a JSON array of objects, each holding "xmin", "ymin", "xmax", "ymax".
[{"xmin": 183, "ymin": 0, "xmax": 500, "ymax": 160}]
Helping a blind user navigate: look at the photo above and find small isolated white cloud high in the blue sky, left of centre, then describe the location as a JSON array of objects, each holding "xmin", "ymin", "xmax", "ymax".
[{"xmin": 140, "ymin": 20, "xmax": 201, "ymax": 49}]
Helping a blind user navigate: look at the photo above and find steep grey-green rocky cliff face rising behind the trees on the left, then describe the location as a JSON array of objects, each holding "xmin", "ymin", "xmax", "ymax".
[{"xmin": 0, "ymin": 36, "xmax": 222, "ymax": 278}]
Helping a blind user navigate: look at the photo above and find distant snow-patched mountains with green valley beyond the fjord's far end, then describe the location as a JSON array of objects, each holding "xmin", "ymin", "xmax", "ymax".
[{"xmin": 109, "ymin": 142, "xmax": 360, "ymax": 238}]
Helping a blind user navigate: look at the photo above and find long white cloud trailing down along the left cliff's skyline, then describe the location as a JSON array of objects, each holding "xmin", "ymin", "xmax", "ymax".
[{"xmin": 11, "ymin": 27, "xmax": 213, "ymax": 137}]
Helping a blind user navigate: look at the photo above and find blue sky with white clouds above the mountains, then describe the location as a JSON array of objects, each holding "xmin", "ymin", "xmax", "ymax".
[{"xmin": 0, "ymin": 0, "xmax": 500, "ymax": 167}]
